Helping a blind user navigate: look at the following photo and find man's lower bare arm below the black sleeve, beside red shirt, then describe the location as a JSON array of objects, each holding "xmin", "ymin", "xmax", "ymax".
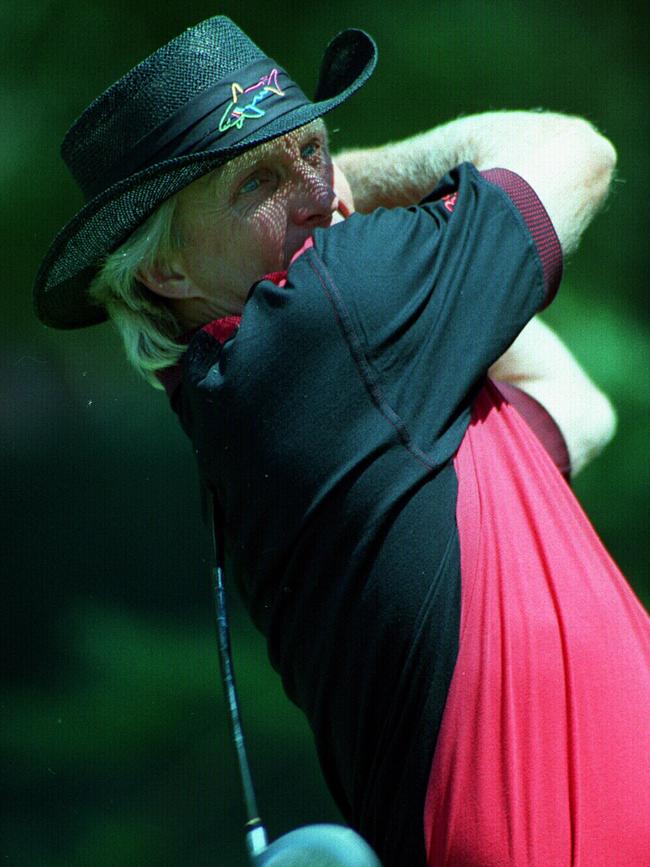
[{"xmin": 489, "ymin": 318, "xmax": 616, "ymax": 475}]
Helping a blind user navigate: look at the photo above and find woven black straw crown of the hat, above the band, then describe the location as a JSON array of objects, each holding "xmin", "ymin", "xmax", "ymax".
[{"xmin": 61, "ymin": 15, "xmax": 266, "ymax": 198}]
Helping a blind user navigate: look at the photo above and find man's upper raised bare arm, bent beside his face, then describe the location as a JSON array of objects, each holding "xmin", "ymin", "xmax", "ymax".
[{"xmin": 336, "ymin": 111, "xmax": 616, "ymax": 255}]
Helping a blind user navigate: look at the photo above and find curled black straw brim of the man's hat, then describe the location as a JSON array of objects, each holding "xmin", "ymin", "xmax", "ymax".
[{"xmin": 34, "ymin": 29, "xmax": 377, "ymax": 329}]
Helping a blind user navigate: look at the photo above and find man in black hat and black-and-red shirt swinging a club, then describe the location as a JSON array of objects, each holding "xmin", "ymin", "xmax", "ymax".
[{"xmin": 35, "ymin": 18, "xmax": 650, "ymax": 867}]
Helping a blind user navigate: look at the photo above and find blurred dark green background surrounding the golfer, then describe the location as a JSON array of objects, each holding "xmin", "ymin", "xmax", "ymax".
[{"xmin": 0, "ymin": 0, "xmax": 650, "ymax": 867}]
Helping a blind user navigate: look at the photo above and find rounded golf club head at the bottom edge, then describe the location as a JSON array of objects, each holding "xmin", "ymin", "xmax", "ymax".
[{"xmin": 253, "ymin": 824, "xmax": 381, "ymax": 867}]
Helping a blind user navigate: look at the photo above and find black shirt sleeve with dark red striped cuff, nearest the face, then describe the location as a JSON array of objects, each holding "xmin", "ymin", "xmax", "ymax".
[{"xmin": 289, "ymin": 163, "xmax": 561, "ymax": 459}]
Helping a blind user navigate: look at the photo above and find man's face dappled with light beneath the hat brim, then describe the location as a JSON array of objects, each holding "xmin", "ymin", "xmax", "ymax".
[{"xmin": 167, "ymin": 121, "xmax": 347, "ymax": 315}]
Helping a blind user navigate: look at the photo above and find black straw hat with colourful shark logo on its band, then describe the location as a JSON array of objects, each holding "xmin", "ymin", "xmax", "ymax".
[{"xmin": 34, "ymin": 16, "xmax": 377, "ymax": 328}]
